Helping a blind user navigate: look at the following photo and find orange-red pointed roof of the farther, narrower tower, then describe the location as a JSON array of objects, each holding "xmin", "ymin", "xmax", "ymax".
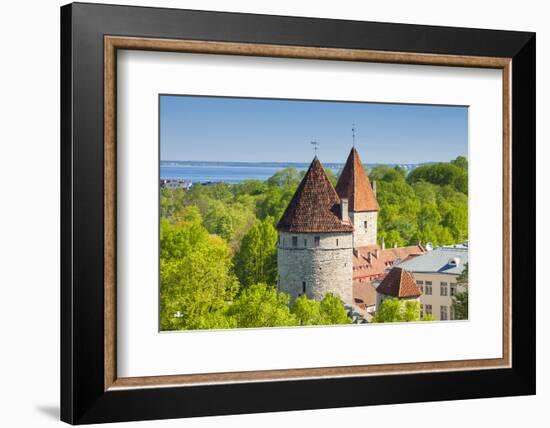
[{"xmin": 336, "ymin": 147, "xmax": 378, "ymax": 212}]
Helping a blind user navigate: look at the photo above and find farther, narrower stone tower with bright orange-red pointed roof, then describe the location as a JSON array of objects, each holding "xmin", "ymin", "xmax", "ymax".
[{"xmin": 336, "ymin": 147, "xmax": 378, "ymax": 248}]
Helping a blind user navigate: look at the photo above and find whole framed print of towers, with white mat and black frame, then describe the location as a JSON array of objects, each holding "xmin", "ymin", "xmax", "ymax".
[{"xmin": 61, "ymin": 3, "xmax": 535, "ymax": 424}]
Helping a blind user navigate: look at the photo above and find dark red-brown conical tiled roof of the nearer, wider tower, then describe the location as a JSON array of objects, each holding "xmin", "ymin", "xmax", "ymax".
[{"xmin": 277, "ymin": 156, "xmax": 353, "ymax": 233}]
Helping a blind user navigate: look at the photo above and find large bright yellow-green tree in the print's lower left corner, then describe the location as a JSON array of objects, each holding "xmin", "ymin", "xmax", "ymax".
[{"xmin": 160, "ymin": 217, "xmax": 238, "ymax": 330}]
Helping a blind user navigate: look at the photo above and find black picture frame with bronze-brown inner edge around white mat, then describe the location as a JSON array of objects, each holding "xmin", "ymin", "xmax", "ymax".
[{"xmin": 61, "ymin": 4, "xmax": 535, "ymax": 424}]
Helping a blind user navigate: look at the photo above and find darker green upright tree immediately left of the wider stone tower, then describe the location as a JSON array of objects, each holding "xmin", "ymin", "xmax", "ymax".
[{"xmin": 235, "ymin": 217, "xmax": 278, "ymax": 287}]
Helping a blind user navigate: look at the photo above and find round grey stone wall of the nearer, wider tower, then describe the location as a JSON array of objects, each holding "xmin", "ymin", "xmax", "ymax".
[{"xmin": 277, "ymin": 232, "xmax": 353, "ymax": 303}]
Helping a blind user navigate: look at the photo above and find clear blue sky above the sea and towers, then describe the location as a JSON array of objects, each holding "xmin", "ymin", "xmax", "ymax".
[{"xmin": 160, "ymin": 95, "xmax": 468, "ymax": 163}]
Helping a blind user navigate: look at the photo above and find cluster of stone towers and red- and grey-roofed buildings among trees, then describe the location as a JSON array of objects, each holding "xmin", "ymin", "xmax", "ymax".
[{"xmin": 277, "ymin": 148, "xmax": 468, "ymax": 320}]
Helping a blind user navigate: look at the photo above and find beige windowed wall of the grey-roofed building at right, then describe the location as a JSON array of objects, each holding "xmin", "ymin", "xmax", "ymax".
[{"xmin": 411, "ymin": 272, "xmax": 465, "ymax": 320}]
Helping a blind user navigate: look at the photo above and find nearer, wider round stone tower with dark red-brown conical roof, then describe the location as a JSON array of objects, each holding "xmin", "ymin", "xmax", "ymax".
[{"xmin": 277, "ymin": 156, "xmax": 353, "ymax": 303}]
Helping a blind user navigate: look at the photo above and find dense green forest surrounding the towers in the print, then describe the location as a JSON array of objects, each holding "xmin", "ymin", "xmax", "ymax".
[{"xmin": 160, "ymin": 157, "xmax": 468, "ymax": 330}]
